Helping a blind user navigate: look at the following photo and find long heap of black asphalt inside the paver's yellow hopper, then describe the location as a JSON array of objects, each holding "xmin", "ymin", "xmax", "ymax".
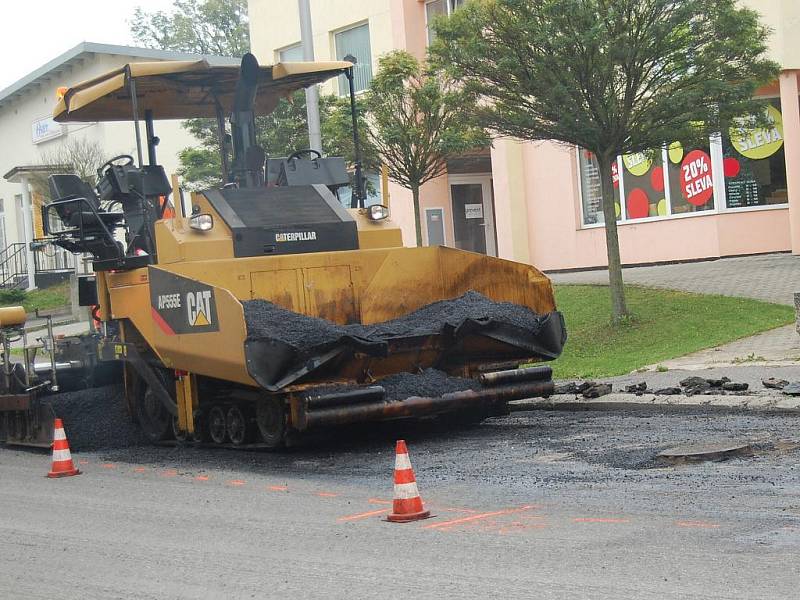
[{"xmin": 242, "ymin": 291, "xmax": 542, "ymax": 352}]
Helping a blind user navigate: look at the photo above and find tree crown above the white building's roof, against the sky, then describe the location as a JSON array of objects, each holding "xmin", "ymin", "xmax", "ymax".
[{"xmin": 129, "ymin": 0, "xmax": 250, "ymax": 57}]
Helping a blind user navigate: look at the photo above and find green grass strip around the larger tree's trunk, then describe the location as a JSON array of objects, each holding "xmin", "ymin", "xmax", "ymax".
[{"xmin": 550, "ymin": 285, "xmax": 794, "ymax": 379}]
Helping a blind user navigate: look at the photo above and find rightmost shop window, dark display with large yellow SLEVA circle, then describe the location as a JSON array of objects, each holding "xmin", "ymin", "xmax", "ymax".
[{"xmin": 722, "ymin": 98, "xmax": 788, "ymax": 208}]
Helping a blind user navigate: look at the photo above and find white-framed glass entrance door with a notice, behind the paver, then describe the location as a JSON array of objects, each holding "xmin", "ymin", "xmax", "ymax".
[{"xmin": 449, "ymin": 176, "xmax": 497, "ymax": 256}]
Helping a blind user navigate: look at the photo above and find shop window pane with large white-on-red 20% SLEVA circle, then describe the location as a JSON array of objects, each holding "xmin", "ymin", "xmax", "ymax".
[{"xmin": 667, "ymin": 142, "xmax": 714, "ymax": 215}]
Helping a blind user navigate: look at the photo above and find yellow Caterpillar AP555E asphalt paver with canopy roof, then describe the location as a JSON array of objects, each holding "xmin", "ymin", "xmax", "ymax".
[{"xmin": 0, "ymin": 55, "xmax": 566, "ymax": 447}]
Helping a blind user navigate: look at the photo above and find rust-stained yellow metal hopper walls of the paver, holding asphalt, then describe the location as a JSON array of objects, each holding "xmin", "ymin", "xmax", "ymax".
[{"xmin": 106, "ymin": 247, "xmax": 555, "ymax": 385}]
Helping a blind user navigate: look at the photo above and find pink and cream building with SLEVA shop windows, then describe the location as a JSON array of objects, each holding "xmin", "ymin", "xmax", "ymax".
[{"xmin": 249, "ymin": 0, "xmax": 800, "ymax": 270}]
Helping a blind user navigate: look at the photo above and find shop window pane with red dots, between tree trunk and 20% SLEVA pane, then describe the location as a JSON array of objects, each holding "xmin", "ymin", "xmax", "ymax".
[{"xmin": 622, "ymin": 149, "xmax": 668, "ymax": 219}]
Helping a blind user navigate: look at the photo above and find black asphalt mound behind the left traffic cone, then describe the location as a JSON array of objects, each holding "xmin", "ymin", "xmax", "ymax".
[{"xmin": 44, "ymin": 385, "xmax": 147, "ymax": 452}]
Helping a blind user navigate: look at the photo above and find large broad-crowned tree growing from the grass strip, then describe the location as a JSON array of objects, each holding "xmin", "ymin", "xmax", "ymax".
[{"xmin": 432, "ymin": 0, "xmax": 778, "ymax": 323}]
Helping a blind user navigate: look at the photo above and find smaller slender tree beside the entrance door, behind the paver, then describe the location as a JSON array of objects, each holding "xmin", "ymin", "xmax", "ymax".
[{"xmin": 366, "ymin": 50, "xmax": 489, "ymax": 246}]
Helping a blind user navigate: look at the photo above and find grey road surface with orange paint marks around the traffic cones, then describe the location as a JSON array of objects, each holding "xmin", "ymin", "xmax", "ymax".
[{"xmin": 0, "ymin": 411, "xmax": 800, "ymax": 600}]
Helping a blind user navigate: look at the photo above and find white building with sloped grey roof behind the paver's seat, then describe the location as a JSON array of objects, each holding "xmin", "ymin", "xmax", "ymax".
[{"xmin": 0, "ymin": 42, "xmax": 238, "ymax": 287}]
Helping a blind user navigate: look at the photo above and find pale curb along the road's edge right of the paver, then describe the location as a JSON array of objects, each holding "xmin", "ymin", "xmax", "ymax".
[{"xmin": 508, "ymin": 393, "xmax": 800, "ymax": 413}]
